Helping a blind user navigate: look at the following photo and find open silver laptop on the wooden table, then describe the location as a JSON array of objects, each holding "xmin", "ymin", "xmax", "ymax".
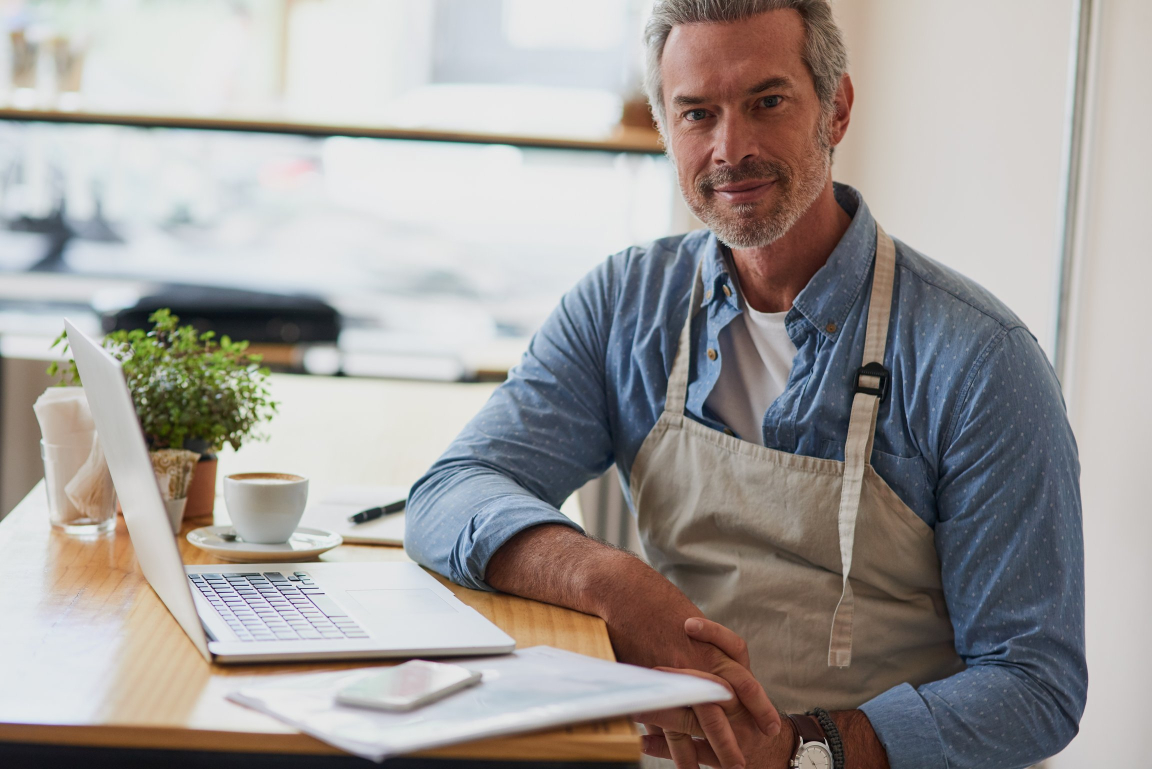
[{"xmin": 65, "ymin": 320, "xmax": 516, "ymax": 663}]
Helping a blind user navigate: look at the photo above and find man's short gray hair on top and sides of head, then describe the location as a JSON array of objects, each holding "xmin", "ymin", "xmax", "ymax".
[{"xmin": 644, "ymin": 0, "xmax": 848, "ymax": 131}]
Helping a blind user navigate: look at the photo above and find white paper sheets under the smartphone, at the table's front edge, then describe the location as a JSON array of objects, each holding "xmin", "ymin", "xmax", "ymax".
[{"xmin": 228, "ymin": 646, "xmax": 729, "ymax": 761}]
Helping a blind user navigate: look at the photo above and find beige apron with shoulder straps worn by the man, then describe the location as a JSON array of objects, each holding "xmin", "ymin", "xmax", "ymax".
[{"xmin": 631, "ymin": 227, "xmax": 964, "ymax": 711}]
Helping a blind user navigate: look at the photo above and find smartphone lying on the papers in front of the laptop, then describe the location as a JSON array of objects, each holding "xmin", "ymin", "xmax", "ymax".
[{"xmin": 336, "ymin": 660, "xmax": 480, "ymax": 710}]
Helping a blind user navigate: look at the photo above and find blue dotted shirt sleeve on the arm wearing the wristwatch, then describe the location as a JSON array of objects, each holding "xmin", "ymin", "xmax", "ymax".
[{"xmin": 862, "ymin": 327, "xmax": 1087, "ymax": 769}]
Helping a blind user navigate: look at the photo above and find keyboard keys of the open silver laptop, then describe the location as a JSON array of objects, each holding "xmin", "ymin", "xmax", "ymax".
[{"xmin": 188, "ymin": 571, "xmax": 367, "ymax": 641}]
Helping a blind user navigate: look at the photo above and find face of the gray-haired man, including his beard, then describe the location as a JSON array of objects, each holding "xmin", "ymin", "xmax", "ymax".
[{"xmin": 660, "ymin": 10, "xmax": 832, "ymax": 249}]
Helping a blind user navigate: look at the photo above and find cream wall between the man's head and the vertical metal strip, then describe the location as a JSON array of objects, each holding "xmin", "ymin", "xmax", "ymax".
[{"xmin": 834, "ymin": 0, "xmax": 1073, "ymax": 349}]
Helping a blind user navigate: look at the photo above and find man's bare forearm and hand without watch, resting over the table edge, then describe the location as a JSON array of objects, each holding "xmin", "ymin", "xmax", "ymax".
[{"xmin": 485, "ymin": 525, "xmax": 781, "ymax": 767}]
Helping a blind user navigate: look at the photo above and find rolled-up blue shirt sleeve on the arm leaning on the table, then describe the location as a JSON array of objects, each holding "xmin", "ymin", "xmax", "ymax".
[{"xmin": 404, "ymin": 260, "xmax": 614, "ymax": 589}]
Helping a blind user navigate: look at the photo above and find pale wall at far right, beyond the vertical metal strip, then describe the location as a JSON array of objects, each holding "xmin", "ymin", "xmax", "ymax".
[{"xmin": 1046, "ymin": 0, "xmax": 1152, "ymax": 769}]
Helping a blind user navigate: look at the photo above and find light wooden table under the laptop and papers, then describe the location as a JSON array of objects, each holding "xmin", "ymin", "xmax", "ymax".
[{"xmin": 0, "ymin": 485, "xmax": 639, "ymax": 769}]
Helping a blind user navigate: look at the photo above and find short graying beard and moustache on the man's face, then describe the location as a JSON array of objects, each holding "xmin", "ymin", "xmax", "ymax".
[{"xmin": 681, "ymin": 115, "xmax": 832, "ymax": 249}]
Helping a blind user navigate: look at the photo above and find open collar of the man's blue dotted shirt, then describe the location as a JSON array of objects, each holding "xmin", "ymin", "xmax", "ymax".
[{"xmin": 700, "ymin": 183, "xmax": 876, "ymax": 338}]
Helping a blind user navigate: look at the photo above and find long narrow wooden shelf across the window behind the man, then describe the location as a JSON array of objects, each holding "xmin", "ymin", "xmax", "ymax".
[{"xmin": 0, "ymin": 108, "xmax": 664, "ymax": 154}]
